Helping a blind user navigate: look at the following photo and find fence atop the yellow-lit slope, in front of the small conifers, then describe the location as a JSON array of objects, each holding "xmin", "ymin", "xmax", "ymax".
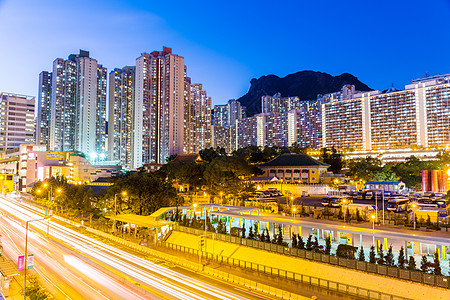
[{"xmin": 174, "ymin": 224, "xmax": 450, "ymax": 289}]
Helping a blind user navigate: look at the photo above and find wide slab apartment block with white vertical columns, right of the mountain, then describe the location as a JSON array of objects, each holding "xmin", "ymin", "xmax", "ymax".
[{"xmin": 322, "ymin": 74, "xmax": 450, "ymax": 151}]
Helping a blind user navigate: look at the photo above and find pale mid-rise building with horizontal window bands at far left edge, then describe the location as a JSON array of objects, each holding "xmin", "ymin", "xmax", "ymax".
[{"xmin": 0, "ymin": 93, "xmax": 35, "ymax": 152}]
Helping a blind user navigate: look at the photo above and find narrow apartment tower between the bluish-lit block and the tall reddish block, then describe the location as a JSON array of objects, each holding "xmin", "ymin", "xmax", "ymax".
[{"xmin": 108, "ymin": 66, "xmax": 136, "ymax": 168}]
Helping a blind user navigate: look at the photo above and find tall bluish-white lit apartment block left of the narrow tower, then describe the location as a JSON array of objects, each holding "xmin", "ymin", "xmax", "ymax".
[{"xmin": 43, "ymin": 50, "xmax": 107, "ymax": 155}]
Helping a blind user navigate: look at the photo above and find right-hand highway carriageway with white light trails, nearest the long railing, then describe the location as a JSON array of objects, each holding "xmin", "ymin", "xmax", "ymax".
[{"xmin": 0, "ymin": 199, "xmax": 265, "ymax": 299}]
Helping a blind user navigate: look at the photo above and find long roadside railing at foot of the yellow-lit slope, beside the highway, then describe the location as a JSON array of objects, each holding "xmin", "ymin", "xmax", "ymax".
[{"xmin": 162, "ymin": 242, "xmax": 410, "ymax": 300}]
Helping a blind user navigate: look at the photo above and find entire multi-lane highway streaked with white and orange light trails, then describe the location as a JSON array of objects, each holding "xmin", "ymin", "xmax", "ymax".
[{"xmin": 0, "ymin": 197, "xmax": 269, "ymax": 299}]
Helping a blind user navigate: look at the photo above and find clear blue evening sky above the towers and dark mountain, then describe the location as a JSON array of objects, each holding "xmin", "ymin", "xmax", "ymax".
[{"xmin": 0, "ymin": 0, "xmax": 450, "ymax": 104}]
